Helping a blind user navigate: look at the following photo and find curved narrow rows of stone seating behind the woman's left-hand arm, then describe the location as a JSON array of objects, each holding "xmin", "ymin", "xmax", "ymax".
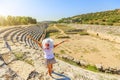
[{"xmin": 0, "ymin": 25, "xmax": 45, "ymax": 49}]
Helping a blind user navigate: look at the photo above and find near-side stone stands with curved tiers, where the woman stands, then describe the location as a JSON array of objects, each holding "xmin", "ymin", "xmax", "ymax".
[{"xmin": 0, "ymin": 25, "xmax": 120, "ymax": 80}]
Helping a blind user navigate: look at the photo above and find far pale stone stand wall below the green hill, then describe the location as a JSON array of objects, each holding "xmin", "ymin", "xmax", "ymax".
[{"xmin": 69, "ymin": 24, "xmax": 120, "ymax": 43}]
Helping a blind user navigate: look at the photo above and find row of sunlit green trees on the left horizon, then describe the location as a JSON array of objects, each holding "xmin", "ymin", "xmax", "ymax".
[{"xmin": 0, "ymin": 15, "xmax": 37, "ymax": 26}]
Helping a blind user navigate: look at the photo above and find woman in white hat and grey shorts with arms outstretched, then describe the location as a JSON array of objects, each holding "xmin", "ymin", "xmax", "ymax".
[{"xmin": 29, "ymin": 36, "xmax": 68, "ymax": 77}]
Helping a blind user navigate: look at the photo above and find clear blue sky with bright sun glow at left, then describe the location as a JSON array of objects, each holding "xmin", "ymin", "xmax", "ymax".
[{"xmin": 0, "ymin": 0, "xmax": 120, "ymax": 21}]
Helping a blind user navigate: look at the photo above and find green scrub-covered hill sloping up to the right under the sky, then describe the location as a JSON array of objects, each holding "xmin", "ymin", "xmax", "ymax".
[{"xmin": 58, "ymin": 9, "xmax": 120, "ymax": 26}]
